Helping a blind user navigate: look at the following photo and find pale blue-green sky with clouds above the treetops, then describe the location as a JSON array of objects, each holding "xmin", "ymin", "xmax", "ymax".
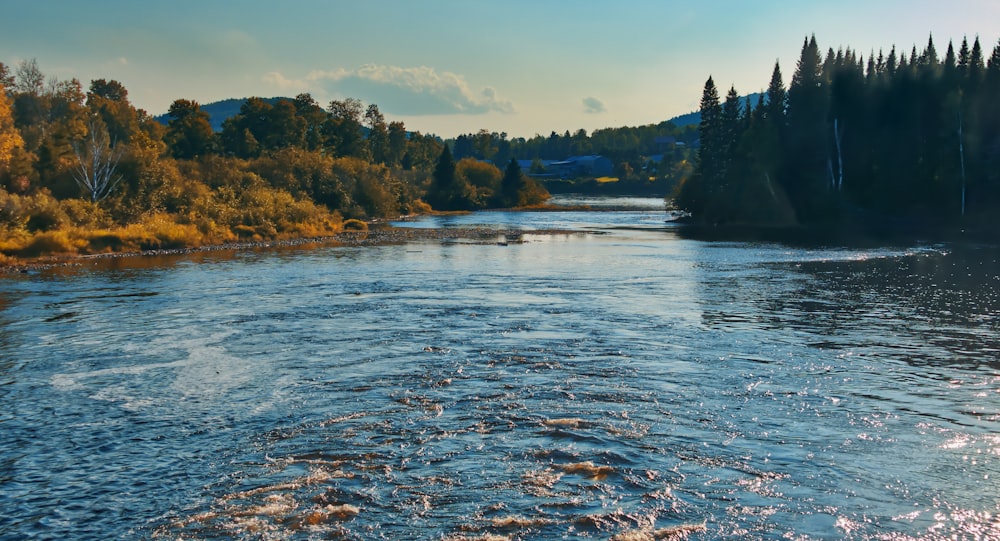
[{"xmin": 0, "ymin": 0, "xmax": 1000, "ymax": 137}]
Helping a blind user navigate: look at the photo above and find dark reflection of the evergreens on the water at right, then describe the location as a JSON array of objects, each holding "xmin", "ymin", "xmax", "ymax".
[{"xmin": 699, "ymin": 246, "xmax": 1000, "ymax": 367}]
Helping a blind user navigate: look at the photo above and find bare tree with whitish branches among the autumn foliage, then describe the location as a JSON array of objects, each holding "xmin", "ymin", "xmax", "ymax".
[{"xmin": 73, "ymin": 118, "xmax": 123, "ymax": 203}]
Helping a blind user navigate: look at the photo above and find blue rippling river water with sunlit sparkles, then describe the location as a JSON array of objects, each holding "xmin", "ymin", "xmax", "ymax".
[{"xmin": 0, "ymin": 202, "xmax": 1000, "ymax": 540}]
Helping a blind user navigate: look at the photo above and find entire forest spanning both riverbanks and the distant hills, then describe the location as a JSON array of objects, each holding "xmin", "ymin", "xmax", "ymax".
[{"xmin": 0, "ymin": 36, "xmax": 1000, "ymax": 263}]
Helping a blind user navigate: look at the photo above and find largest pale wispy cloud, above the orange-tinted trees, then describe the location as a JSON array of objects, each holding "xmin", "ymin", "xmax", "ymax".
[{"xmin": 264, "ymin": 64, "xmax": 514, "ymax": 116}]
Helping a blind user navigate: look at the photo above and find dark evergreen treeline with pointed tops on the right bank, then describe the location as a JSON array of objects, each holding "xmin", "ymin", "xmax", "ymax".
[{"xmin": 677, "ymin": 32, "xmax": 1000, "ymax": 228}]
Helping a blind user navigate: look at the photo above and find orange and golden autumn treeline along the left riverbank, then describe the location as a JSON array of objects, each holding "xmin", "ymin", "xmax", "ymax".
[{"xmin": 0, "ymin": 60, "xmax": 548, "ymax": 259}]
